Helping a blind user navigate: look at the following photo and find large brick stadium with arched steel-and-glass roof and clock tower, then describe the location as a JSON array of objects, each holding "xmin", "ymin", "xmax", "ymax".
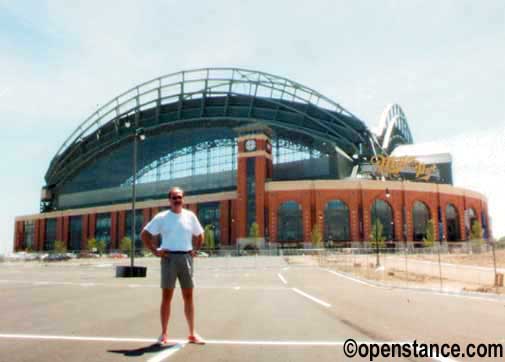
[{"xmin": 14, "ymin": 68, "xmax": 491, "ymax": 251}]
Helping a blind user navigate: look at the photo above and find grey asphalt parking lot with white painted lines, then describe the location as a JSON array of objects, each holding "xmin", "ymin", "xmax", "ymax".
[{"xmin": 0, "ymin": 256, "xmax": 505, "ymax": 362}]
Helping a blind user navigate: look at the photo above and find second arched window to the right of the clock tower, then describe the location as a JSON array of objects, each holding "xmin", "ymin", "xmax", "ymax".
[{"xmin": 324, "ymin": 200, "xmax": 350, "ymax": 241}]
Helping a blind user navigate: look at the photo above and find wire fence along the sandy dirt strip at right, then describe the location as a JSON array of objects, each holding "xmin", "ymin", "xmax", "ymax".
[{"xmin": 317, "ymin": 245, "xmax": 505, "ymax": 293}]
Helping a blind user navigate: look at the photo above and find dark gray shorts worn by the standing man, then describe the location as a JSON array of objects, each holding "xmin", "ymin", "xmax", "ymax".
[{"xmin": 160, "ymin": 254, "xmax": 194, "ymax": 289}]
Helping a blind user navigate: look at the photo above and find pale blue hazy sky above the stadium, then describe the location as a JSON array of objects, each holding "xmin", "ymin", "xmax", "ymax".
[{"xmin": 0, "ymin": 0, "xmax": 505, "ymax": 254}]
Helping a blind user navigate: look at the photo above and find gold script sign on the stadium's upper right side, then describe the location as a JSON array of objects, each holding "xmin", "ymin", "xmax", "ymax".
[{"xmin": 371, "ymin": 155, "xmax": 437, "ymax": 181}]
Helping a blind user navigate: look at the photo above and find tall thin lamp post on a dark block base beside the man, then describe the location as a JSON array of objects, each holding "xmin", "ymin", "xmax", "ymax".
[{"xmin": 116, "ymin": 121, "xmax": 147, "ymax": 278}]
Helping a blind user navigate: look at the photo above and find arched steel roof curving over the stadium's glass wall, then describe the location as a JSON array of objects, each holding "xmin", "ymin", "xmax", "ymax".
[{"xmin": 46, "ymin": 68, "xmax": 380, "ymax": 185}]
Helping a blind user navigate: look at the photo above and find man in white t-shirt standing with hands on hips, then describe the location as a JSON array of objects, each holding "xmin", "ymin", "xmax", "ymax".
[{"xmin": 140, "ymin": 187, "xmax": 204, "ymax": 344}]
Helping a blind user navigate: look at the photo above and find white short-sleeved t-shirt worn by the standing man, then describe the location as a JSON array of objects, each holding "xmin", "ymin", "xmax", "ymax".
[{"xmin": 144, "ymin": 209, "xmax": 203, "ymax": 251}]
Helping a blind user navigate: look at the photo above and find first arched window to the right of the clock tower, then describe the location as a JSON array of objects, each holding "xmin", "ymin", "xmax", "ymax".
[{"xmin": 277, "ymin": 201, "xmax": 303, "ymax": 241}]
